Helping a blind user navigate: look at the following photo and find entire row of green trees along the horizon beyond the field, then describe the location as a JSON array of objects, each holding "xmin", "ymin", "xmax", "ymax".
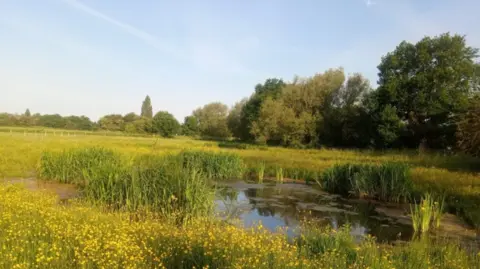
[{"xmin": 0, "ymin": 33, "xmax": 480, "ymax": 155}]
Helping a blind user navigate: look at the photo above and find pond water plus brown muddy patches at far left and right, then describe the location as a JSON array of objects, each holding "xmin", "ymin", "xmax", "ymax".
[{"xmin": 6, "ymin": 178, "xmax": 479, "ymax": 243}]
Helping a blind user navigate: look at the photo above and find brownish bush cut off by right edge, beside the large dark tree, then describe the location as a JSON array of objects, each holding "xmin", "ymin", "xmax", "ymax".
[{"xmin": 457, "ymin": 95, "xmax": 480, "ymax": 157}]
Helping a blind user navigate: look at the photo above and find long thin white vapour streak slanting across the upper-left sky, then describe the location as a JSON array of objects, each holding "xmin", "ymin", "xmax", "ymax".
[{"xmin": 62, "ymin": 0, "xmax": 186, "ymax": 59}]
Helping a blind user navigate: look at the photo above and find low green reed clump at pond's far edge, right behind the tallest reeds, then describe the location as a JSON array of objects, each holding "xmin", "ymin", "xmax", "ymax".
[{"xmin": 179, "ymin": 151, "xmax": 244, "ymax": 180}]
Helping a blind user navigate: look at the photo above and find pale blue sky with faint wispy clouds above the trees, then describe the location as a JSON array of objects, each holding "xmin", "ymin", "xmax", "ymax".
[{"xmin": 0, "ymin": 0, "xmax": 480, "ymax": 120}]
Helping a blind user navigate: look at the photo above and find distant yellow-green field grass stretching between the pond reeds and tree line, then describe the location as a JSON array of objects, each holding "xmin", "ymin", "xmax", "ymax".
[{"xmin": 0, "ymin": 132, "xmax": 480, "ymax": 227}]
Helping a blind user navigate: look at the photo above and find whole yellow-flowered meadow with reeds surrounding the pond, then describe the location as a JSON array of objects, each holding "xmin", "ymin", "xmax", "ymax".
[{"xmin": 0, "ymin": 132, "xmax": 480, "ymax": 268}]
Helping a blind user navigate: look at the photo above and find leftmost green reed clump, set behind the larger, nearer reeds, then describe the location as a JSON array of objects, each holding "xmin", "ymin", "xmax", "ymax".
[{"xmin": 38, "ymin": 147, "xmax": 123, "ymax": 184}]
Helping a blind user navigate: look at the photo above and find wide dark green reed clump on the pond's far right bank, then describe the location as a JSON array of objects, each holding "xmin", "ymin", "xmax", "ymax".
[{"xmin": 319, "ymin": 163, "xmax": 413, "ymax": 202}]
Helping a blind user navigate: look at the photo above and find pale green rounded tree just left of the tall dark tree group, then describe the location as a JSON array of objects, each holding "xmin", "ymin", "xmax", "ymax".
[{"xmin": 193, "ymin": 102, "xmax": 230, "ymax": 138}]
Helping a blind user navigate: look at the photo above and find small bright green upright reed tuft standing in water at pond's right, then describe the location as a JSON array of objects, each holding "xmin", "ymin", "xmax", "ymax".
[{"xmin": 410, "ymin": 193, "xmax": 445, "ymax": 233}]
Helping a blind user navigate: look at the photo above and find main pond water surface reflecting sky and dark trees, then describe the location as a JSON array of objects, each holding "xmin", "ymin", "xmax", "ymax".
[{"xmin": 216, "ymin": 182, "xmax": 413, "ymax": 241}]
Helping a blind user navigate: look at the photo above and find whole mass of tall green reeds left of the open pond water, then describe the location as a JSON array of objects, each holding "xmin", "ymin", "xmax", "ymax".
[{"xmin": 38, "ymin": 148, "xmax": 218, "ymax": 225}]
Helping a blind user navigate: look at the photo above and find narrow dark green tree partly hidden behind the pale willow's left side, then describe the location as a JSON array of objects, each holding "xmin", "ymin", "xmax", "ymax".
[{"xmin": 239, "ymin": 78, "xmax": 285, "ymax": 140}]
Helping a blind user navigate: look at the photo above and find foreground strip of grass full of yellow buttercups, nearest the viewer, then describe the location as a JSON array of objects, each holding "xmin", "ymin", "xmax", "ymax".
[{"xmin": 0, "ymin": 184, "xmax": 480, "ymax": 269}]
